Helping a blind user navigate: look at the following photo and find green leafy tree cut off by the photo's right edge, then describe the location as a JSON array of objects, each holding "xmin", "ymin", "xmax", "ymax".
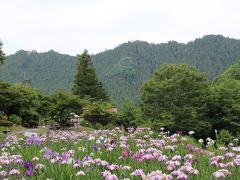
[{"xmin": 208, "ymin": 62, "xmax": 240, "ymax": 135}]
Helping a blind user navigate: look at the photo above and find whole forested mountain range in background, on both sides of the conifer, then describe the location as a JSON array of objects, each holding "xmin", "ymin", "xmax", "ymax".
[{"xmin": 0, "ymin": 35, "xmax": 240, "ymax": 104}]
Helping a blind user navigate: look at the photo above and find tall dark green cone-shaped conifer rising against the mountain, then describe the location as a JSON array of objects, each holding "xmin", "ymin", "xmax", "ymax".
[{"xmin": 72, "ymin": 50, "xmax": 107, "ymax": 100}]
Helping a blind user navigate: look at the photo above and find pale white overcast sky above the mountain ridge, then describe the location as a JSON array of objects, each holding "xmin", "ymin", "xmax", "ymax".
[{"xmin": 0, "ymin": 0, "xmax": 240, "ymax": 55}]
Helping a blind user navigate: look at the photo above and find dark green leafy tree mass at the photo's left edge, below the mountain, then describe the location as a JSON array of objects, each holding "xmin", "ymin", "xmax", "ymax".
[{"xmin": 0, "ymin": 81, "xmax": 41, "ymax": 127}]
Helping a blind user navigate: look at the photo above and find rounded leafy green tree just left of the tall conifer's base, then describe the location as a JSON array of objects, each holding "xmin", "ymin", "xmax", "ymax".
[{"xmin": 49, "ymin": 91, "xmax": 82, "ymax": 127}]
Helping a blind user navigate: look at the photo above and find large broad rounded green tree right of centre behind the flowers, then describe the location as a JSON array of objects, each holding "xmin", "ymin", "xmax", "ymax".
[{"xmin": 142, "ymin": 64, "xmax": 211, "ymax": 136}]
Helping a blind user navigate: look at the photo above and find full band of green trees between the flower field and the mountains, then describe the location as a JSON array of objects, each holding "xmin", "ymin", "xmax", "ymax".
[{"xmin": 0, "ymin": 41, "xmax": 240, "ymax": 140}]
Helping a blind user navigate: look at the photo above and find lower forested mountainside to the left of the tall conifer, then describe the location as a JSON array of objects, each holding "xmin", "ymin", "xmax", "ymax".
[{"xmin": 0, "ymin": 50, "xmax": 76, "ymax": 93}]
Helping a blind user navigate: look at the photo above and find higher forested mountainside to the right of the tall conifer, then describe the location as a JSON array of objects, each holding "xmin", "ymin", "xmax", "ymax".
[{"xmin": 93, "ymin": 35, "xmax": 240, "ymax": 102}]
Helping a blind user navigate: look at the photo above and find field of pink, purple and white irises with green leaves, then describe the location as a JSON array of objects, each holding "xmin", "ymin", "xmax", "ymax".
[{"xmin": 0, "ymin": 128, "xmax": 240, "ymax": 180}]
